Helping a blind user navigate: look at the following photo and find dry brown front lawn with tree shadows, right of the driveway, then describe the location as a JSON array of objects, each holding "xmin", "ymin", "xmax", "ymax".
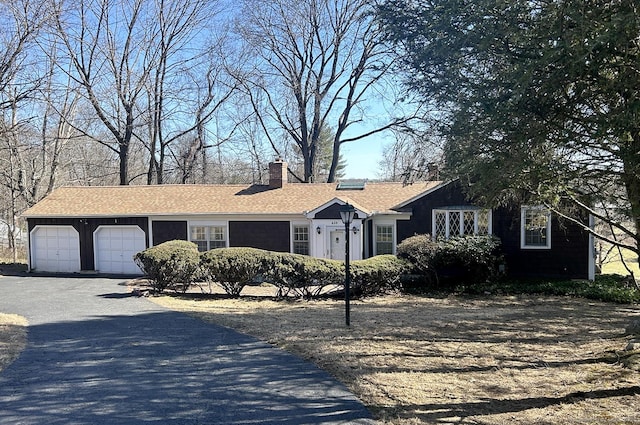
[{"xmin": 153, "ymin": 288, "xmax": 640, "ymax": 425}]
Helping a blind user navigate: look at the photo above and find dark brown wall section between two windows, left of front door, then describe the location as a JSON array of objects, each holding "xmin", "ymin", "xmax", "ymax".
[{"xmin": 229, "ymin": 221, "xmax": 291, "ymax": 252}]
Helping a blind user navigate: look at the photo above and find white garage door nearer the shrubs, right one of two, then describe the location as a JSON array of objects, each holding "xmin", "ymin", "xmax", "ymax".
[{"xmin": 93, "ymin": 226, "xmax": 146, "ymax": 274}]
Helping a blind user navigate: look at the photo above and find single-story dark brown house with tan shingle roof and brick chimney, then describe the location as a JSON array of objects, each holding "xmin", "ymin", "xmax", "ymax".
[{"xmin": 23, "ymin": 160, "xmax": 595, "ymax": 279}]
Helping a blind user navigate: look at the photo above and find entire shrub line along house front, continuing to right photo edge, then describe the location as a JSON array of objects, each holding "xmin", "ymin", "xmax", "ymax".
[{"xmin": 135, "ymin": 236, "xmax": 640, "ymax": 302}]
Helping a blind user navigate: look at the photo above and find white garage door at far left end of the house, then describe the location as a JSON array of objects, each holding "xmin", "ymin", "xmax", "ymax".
[{"xmin": 31, "ymin": 226, "xmax": 80, "ymax": 273}]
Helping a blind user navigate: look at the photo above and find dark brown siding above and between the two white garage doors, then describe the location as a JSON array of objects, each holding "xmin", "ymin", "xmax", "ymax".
[{"xmin": 27, "ymin": 217, "xmax": 149, "ymax": 270}]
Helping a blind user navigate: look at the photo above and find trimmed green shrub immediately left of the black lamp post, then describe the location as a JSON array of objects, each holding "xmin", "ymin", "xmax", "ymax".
[{"xmin": 265, "ymin": 252, "xmax": 344, "ymax": 299}]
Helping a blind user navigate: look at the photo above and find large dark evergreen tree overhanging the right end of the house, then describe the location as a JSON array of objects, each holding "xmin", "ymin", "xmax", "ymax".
[{"xmin": 379, "ymin": 0, "xmax": 640, "ymax": 254}]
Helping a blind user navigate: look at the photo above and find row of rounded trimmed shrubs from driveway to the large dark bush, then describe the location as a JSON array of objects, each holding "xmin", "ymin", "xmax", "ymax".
[{"xmin": 134, "ymin": 241, "xmax": 410, "ymax": 298}]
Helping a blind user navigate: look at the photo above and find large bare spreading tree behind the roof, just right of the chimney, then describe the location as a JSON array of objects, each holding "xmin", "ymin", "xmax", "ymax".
[{"xmin": 238, "ymin": 0, "xmax": 406, "ymax": 182}]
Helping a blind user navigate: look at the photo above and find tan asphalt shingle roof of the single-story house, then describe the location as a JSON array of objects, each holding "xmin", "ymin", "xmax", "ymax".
[{"xmin": 23, "ymin": 182, "xmax": 442, "ymax": 218}]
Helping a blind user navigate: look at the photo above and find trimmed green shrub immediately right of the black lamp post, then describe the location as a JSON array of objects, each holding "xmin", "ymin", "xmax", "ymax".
[{"xmin": 350, "ymin": 255, "xmax": 411, "ymax": 297}]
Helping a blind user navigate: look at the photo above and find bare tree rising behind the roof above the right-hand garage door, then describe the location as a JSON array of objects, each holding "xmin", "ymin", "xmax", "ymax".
[{"xmin": 55, "ymin": 0, "xmax": 157, "ymax": 185}]
